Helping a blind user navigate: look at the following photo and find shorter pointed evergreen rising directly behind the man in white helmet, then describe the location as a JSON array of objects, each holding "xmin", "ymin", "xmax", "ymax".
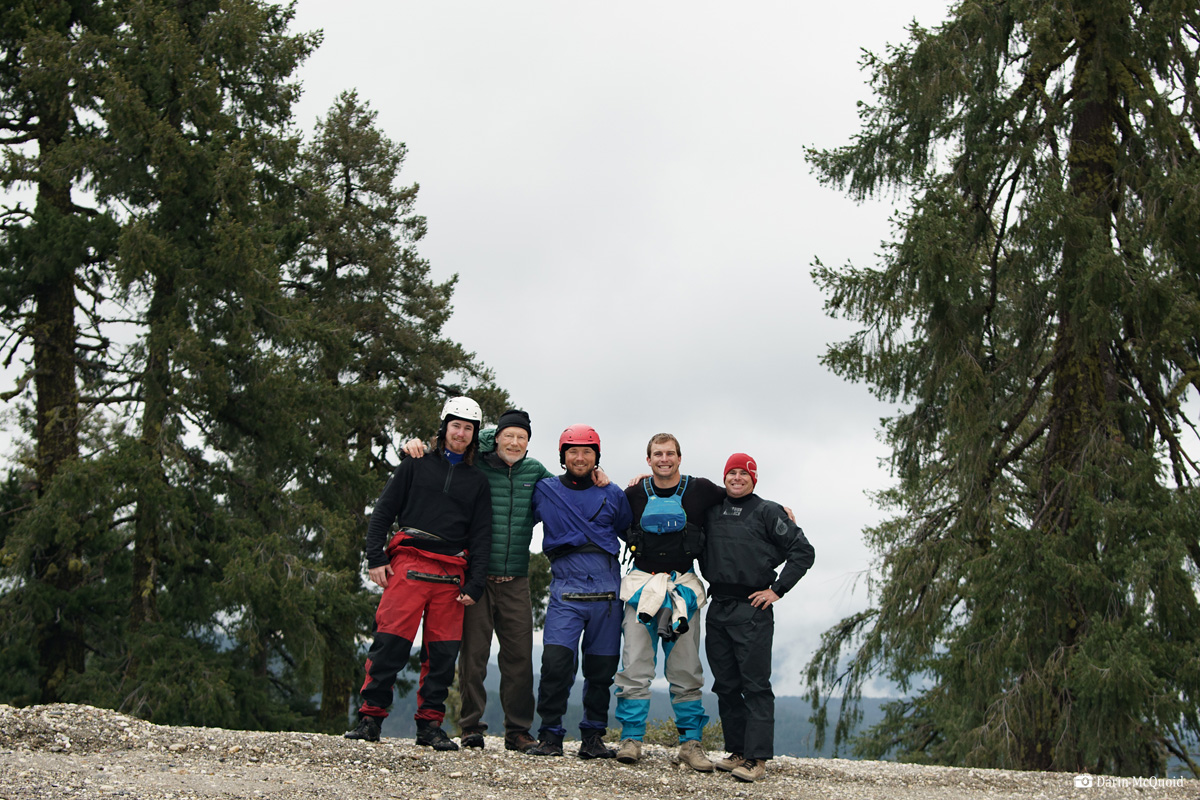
[{"xmin": 286, "ymin": 92, "xmax": 506, "ymax": 730}]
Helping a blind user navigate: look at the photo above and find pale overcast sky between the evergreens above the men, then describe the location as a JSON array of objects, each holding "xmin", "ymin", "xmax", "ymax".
[{"xmin": 285, "ymin": 0, "xmax": 947, "ymax": 694}]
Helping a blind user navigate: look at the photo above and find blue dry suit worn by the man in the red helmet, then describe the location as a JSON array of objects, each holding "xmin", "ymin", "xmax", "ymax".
[{"xmin": 533, "ymin": 477, "xmax": 632, "ymax": 740}]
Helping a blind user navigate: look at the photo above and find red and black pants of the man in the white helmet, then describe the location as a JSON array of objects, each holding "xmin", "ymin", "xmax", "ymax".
[{"xmin": 359, "ymin": 547, "xmax": 466, "ymax": 724}]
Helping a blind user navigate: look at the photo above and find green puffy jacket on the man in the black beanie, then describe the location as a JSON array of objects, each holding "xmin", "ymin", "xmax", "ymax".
[{"xmin": 476, "ymin": 428, "xmax": 554, "ymax": 578}]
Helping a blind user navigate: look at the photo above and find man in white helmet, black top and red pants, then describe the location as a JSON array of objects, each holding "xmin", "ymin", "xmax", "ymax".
[{"xmin": 346, "ymin": 397, "xmax": 492, "ymax": 750}]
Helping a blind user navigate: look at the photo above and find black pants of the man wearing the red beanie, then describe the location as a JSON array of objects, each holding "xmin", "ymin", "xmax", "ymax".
[{"xmin": 704, "ymin": 597, "xmax": 775, "ymax": 758}]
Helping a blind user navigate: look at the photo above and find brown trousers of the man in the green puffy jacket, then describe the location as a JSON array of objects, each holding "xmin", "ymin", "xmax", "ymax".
[{"xmin": 458, "ymin": 578, "xmax": 533, "ymax": 736}]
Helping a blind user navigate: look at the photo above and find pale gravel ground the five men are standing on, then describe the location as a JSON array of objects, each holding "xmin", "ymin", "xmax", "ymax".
[{"xmin": 0, "ymin": 705, "xmax": 1200, "ymax": 800}]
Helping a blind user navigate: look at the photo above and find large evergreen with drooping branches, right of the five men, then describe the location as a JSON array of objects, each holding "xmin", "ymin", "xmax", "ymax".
[{"xmin": 808, "ymin": 0, "xmax": 1200, "ymax": 775}]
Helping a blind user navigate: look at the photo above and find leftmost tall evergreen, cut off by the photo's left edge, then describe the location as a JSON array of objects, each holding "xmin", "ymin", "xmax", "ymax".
[{"xmin": 0, "ymin": 0, "xmax": 115, "ymax": 702}]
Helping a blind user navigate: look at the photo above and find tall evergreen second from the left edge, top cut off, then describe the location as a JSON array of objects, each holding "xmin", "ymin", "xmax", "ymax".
[{"xmin": 78, "ymin": 0, "xmax": 324, "ymax": 727}]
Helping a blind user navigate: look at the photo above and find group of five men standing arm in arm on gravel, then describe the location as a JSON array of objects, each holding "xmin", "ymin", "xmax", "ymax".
[{"xmin": 346, "ymin": 397, "xmax": 814, "ymax": 781}]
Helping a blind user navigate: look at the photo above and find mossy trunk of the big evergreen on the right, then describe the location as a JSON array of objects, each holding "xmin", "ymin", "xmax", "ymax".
[{"xmin": 1022, "ymin": 4, "xmax": 1120, "ymax": 770}]
